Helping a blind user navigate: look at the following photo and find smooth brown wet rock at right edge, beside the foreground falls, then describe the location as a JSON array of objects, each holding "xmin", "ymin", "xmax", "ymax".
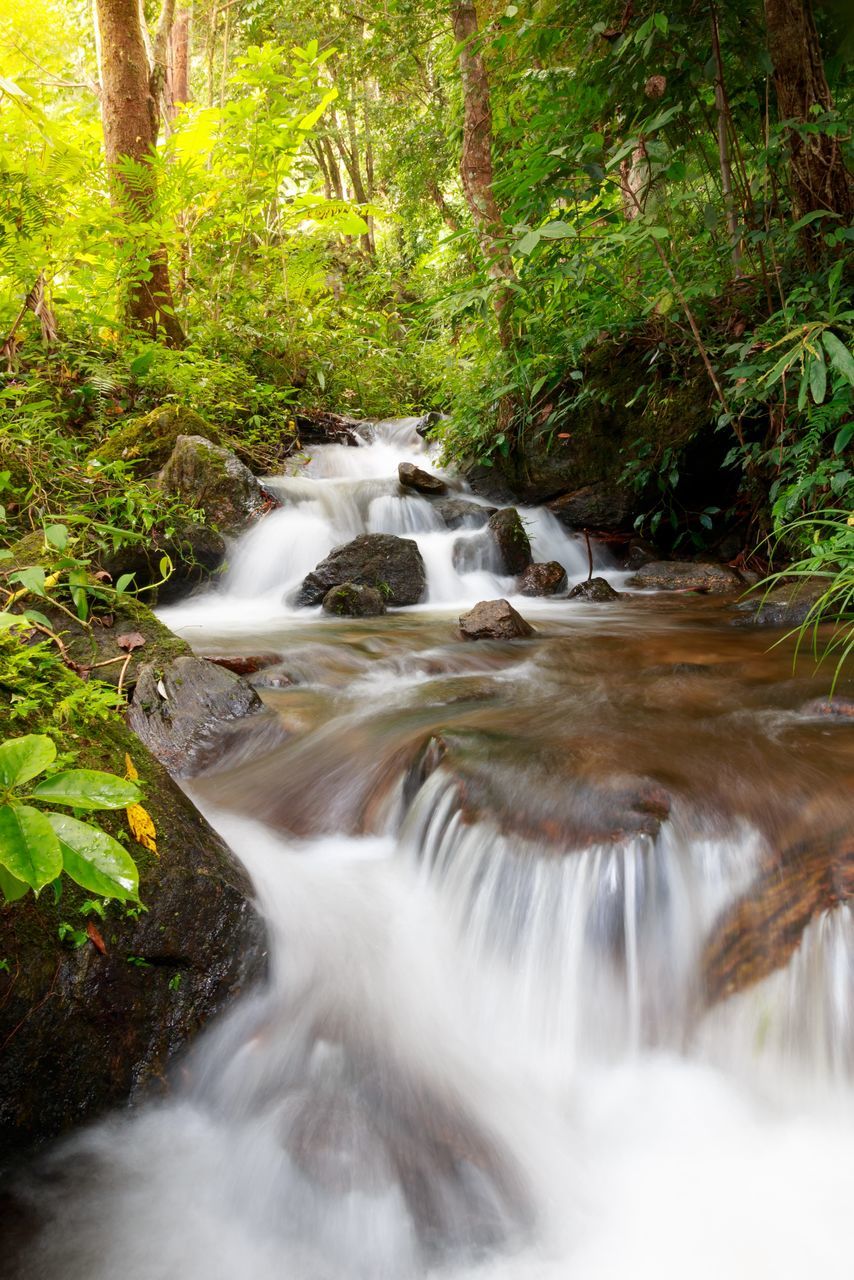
[{"xmin": 703, "ymin": 831, "xmax": 854, "ymax": 1005}]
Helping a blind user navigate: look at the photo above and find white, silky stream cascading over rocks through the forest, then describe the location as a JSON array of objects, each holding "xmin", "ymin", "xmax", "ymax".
[{"xmin": 6, "ymin": 420, "xmax": 854, "ymax": 1280}]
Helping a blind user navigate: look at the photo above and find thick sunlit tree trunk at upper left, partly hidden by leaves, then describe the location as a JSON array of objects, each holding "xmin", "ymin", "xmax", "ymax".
[{"xmin": 96, "ymin": 0, "xmax": 184, "ymax": 347}]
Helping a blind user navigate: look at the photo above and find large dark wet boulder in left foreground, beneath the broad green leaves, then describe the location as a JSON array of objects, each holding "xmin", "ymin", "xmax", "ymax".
[{"xmin": 0, "ymin": 717, "xmax": 265, "ymax": 1156}]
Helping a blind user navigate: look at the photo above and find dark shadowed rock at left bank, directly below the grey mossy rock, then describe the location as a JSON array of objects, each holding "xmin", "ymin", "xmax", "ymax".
[{"xmin": 97, "ymin": 520, "xmax": 225, "ymax": 604}]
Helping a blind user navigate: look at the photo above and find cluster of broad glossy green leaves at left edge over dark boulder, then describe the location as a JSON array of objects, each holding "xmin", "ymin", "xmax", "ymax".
[{"xmin": 0, "ymin": 733, "xmax": 140, "ymax": 902}]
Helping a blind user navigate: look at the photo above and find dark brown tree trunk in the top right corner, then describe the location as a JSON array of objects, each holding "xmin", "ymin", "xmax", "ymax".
[{"xmin": 764, "ymin": 0, "xmax": 853, "ymax": 232}]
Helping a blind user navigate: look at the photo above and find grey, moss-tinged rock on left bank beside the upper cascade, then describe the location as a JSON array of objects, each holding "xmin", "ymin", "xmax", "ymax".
[{"xmin": 156, "ymin": 435, "xmax": 266, "ymax": 534}]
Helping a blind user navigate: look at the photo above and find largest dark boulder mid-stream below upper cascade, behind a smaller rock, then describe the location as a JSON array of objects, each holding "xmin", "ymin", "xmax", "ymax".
[{"xmin": 296, "ymin": 534, "xmax": 426, "ymax": 604}]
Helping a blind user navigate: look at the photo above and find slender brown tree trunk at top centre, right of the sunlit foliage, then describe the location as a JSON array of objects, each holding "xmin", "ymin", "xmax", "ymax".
[{"xmin": 451, "ymin": 0, "xmax": 516, "ymax": 351}]
